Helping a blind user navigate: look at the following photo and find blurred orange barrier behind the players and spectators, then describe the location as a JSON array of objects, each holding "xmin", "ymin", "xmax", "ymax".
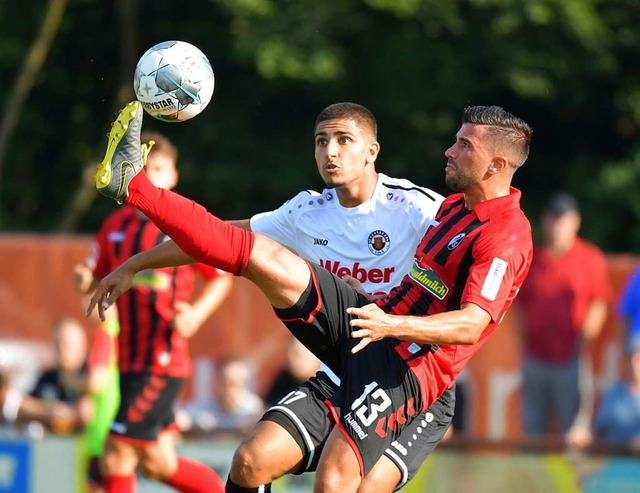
[{"xmin": 0, "ymin": 234, "xmax": 638, "ymax": 440}]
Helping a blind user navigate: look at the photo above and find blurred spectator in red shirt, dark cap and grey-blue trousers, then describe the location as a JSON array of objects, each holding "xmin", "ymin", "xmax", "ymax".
[{"xmin": 516, "ymin": 193, "xmax": 611, "ymax": 444}]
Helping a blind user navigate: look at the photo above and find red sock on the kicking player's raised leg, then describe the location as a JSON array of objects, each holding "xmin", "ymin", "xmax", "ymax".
[{"xmin": 127, "ymin": 173, "xmax": 253, "ymax": 276}]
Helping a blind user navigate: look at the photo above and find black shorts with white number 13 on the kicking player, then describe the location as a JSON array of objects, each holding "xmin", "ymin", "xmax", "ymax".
[{"xmin": 276, "ymin": 263, "xmax": 430, "ymax": 477}]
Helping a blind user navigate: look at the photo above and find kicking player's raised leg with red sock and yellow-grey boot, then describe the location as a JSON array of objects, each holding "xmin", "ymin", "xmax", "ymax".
[{"xmin": 96, "ymin": 102, "xmax": 311, "ymax": 308}]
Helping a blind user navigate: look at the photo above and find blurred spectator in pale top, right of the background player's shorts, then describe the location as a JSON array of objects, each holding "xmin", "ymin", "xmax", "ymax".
[{"xmin": 183, "ymin": 358, "xmax": 264, "ymax": 435}]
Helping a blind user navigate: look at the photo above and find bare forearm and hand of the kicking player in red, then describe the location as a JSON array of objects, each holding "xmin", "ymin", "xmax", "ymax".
[{"xmin": 347, "ymin": 303, "xmax": 491, "ymax": 353}]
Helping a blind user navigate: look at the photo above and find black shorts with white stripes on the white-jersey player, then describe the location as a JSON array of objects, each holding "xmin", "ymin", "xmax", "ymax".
[{"xmin": 261, "ymin": 371, "xmax": 455, "ymax": 489}]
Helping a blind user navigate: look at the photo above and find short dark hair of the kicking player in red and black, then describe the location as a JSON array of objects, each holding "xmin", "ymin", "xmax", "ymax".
[{"xmin": 462, "ymin": 106, "xmax": 533, "ymax": 169}]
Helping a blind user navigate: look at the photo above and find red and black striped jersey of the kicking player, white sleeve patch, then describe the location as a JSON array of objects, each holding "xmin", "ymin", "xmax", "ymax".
[{"xmin": 377, "ymin": 188, "xmax": 533, "ymax": 403}]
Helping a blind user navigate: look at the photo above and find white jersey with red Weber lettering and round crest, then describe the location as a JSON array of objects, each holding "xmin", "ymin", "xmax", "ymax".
[{"xmin": 251, "ymin": 173, "xmax": 444, "ymax": 384}]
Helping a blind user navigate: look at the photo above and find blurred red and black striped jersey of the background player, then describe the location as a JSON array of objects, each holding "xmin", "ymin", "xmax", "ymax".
[{"xmin": 94, "ymin": 206, "xmax": 218, "ymax": 377}]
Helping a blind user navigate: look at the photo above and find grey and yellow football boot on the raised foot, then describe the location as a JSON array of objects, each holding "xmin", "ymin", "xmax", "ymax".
[{"xmin": 94, "ymin": 101, "xmax": 153, "ymax": 204}]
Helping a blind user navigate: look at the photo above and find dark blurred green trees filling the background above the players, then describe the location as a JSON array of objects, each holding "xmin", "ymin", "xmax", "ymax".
[{"xmin": 0, "ymin": 0, "xmax": 640, "ymax": 252}]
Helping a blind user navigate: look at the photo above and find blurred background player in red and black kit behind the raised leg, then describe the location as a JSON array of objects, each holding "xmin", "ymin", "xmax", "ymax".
[{"xmin": 78, "ymin": 133, "xmax": 232, "ymax": 493}]
